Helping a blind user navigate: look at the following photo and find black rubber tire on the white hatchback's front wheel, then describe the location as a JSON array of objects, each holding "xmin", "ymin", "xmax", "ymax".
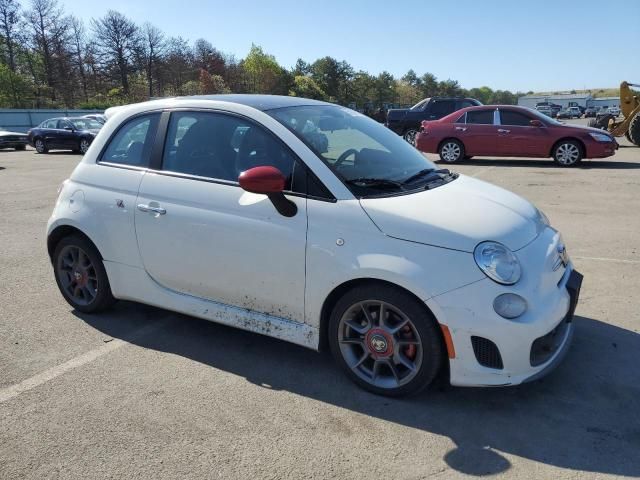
[{"xmin": 328, "ymin": 283, "xmax": 445, "ymax": 397}]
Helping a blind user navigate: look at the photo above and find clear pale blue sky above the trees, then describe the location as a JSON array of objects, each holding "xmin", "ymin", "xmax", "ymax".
[{"xmin": 60, "ymin": 0, "xmax": 640, "ymax": 92}]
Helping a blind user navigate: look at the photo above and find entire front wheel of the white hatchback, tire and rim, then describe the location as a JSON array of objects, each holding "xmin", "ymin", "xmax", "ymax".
[{"xmin": 329, "ymin": 284, "xmax": 444, "ymax": 396}]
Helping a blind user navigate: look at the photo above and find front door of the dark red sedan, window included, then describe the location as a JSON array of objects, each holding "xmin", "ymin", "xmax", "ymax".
[{"xmin": 498, "ymin": 108, "xmax": 549, "ymax": 157}]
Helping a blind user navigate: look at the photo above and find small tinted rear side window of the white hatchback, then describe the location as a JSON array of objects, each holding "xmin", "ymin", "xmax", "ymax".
[{"xmin": 101, "ymin": 113, "xmax": 160, "ymax": 167}]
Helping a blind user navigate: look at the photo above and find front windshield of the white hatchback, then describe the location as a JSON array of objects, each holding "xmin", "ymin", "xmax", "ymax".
[{"xmin": 266, "ymin": 105, "xmax": 436, "ymax": 196}]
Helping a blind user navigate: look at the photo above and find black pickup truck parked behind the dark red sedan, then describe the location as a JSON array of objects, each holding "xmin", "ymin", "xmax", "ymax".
[{"xmin": 386, "ymin": 97, "xmax": 482, "ymax": 145}]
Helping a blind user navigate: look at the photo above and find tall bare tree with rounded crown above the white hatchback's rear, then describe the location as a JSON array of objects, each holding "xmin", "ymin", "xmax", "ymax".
[{"xmin": 91, "ymin": 10, "xmax": 140, "ymax": 95}]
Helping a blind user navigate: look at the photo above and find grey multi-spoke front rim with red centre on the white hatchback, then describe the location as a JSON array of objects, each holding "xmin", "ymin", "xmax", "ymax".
[{"xmin": 338, "ymin": 300, "xmax": 423, "ymax": 389}]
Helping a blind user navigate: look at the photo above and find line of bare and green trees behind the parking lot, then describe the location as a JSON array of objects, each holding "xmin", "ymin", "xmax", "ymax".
[{"xmin": 0, "ymin": 0, "xmax": 523, "ymax": 111}]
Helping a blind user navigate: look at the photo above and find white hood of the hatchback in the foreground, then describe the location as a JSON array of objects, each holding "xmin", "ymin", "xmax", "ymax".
[{"xmin": 360, "ymin": 175, "xmax": 545, "ymax": 252}]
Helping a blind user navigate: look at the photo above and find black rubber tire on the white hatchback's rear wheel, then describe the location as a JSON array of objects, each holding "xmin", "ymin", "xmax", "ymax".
[{"xmin": 53, "ymin": 234, "xmax": 116, "ymax": 313}]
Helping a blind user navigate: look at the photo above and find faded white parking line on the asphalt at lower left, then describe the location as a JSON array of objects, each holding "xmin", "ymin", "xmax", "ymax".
[{"xmin": 0, "ymin": 320, "xmax": 168, "ymax": 403}]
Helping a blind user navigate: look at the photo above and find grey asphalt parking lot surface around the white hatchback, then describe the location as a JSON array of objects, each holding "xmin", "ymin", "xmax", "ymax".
[{"xmin": 0, "ymin": 129, "xmax": 640, "ymax": 479}]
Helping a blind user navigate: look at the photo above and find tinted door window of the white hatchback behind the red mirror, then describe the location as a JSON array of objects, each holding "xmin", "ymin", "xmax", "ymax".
[{"xmin": 162, "ymin": 112, "xmax": 296, "ymax": 190}]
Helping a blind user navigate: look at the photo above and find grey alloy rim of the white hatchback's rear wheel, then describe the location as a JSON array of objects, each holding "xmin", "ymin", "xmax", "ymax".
[{"xmin": 56, "ymin": 245, "xmax": 98, "ymax": 305}]
